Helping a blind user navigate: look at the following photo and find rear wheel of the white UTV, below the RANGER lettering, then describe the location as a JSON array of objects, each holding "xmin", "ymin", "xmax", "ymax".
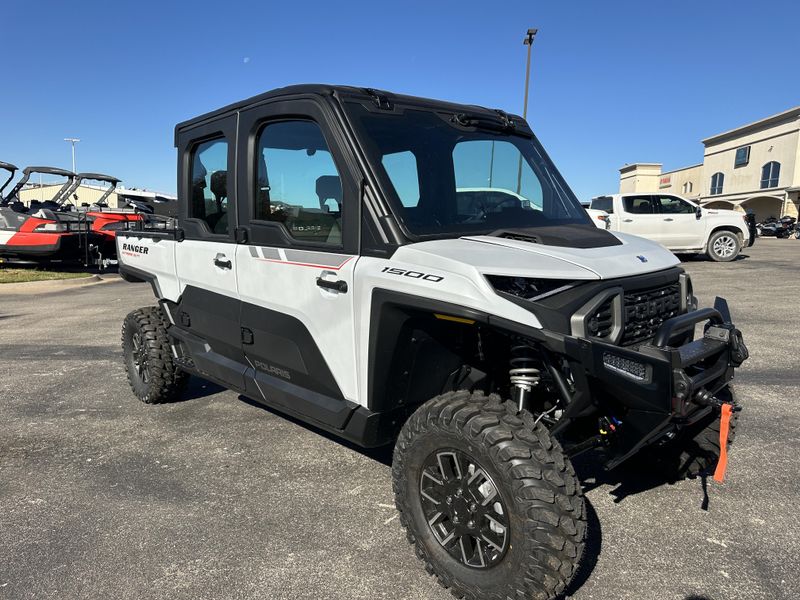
[{"xmin": 122, "ymin": 306, "xmax": 187, "ymax": 404}]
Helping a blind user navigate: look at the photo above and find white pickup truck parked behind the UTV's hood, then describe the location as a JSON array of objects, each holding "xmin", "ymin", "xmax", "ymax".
[{"xmin": 589, "ymin": 193, "xmax": 755, "ymax": 262}]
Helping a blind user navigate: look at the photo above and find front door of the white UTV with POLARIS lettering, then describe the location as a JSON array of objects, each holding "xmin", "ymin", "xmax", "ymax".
[{"xmin": 231, "ymin": 99, "xmax": 359, "ymax": 428}]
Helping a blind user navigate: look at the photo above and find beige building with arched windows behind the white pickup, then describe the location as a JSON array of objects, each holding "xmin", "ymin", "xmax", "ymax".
[{"xmin": 619, "ymin": 106, "xmax": 800, "ymax": 220}]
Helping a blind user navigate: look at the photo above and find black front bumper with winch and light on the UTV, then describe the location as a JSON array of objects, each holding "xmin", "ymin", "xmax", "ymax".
[{"xmin": 555, "ymin": 301, "xmax": 747, "ymax": 468}]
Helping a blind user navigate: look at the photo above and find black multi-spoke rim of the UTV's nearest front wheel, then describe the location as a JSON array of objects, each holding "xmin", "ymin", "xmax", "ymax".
[{"xmin": 419, "ymin": 449, "xmax": 509, "ymax": 569}]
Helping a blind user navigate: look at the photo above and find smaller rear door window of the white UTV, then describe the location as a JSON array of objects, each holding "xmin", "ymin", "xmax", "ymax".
[{"xmin": 189, "ymin": 138, "xmax": 229, "ymax": 234}]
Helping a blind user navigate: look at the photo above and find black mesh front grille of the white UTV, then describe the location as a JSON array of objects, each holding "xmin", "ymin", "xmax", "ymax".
[{"xmin": 620, "ymin": 282, "xmax": 681, "ymax": 346}]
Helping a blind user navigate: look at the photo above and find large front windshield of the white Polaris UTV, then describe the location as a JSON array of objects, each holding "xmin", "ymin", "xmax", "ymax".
[{"xmin": 347, "ymin": 102, "xmax": 591, "ymax": 236}]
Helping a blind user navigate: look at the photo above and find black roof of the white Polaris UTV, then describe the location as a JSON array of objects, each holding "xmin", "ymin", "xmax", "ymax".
[{"xmin": 175, "ymin": 83, "xmax": 527, "ymax": 140}]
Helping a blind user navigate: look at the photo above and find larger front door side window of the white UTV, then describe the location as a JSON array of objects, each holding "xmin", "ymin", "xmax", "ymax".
[{"xmin": 254, "ymin": 121, "xmax": 343, "ymax": 245}]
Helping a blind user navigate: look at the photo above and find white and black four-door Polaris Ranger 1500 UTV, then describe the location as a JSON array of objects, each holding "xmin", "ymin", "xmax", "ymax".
[{"xmin": 117, "ymin": 85, "xmax": 747, "ymax": 598}]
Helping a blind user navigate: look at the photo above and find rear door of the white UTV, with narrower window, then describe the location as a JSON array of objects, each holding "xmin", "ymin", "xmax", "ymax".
[{"xmin": 173, "ymin": 116, "xmax": 245, "ymax": 389}]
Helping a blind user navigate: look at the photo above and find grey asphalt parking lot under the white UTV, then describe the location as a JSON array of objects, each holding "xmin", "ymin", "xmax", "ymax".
[{"xmin": 0, "ymin": 240, "xmax": 800, "ymax": 600}]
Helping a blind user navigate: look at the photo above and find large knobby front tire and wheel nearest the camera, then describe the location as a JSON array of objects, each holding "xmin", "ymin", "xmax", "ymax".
[{"xmin": 392, "ymin": 391, "xmax": 586, "ymax": 599}]
